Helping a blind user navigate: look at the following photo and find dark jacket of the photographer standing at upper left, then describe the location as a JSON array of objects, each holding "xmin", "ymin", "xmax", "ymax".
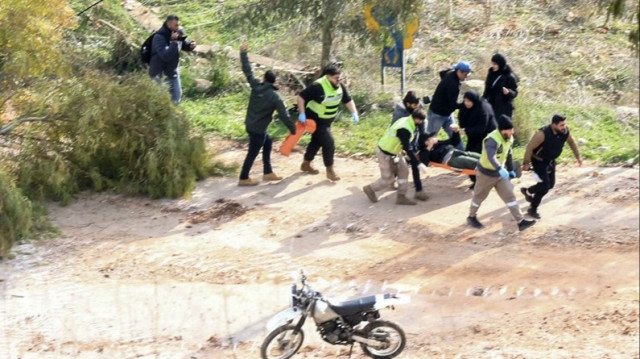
[{"xmin": 149, "ymin": 23, "xmax": 191, "ymax": 78}]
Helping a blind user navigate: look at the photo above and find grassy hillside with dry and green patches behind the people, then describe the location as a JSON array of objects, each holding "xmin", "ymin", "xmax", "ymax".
[{"xmin": 96, "ymin": 0, "xmax": 639, "ymax": 163}]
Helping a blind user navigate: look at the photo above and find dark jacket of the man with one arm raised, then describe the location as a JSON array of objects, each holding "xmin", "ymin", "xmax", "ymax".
[{"xmin": 240, "ymin": 51, "xmax": 296, "ymax": 134}]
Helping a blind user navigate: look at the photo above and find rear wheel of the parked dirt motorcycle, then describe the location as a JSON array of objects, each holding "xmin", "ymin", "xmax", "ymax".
[{"xmin": 360, "ymin": 320, "xmax": 407, "ymax": 359}]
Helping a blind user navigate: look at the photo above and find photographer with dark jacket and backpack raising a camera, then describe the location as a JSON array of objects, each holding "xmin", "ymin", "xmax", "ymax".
[{"xmin": 149, "ymin": 15, "xmax": 196, "ymax": 104}]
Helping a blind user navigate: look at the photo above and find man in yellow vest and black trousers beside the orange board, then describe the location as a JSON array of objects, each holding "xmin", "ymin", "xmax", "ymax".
[{"xmin": 298, "ymin": 65, "xmax": 360, "ymax": 181}]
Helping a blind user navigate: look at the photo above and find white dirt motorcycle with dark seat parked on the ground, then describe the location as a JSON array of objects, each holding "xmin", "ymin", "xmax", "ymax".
[{"xmin": 260, "ymin": 271, "xmax": 409, "ymax": 359}]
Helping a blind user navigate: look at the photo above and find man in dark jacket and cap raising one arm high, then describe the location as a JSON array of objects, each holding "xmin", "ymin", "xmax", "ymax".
[{"xmin": 238, "ymin": 44, "xmax": 296, "ymax": 186}]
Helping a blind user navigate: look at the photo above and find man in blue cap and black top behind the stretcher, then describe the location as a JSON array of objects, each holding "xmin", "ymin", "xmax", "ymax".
[{"xmin": 427, "ymin": 61, "xmax": 471, "ymax": 150}]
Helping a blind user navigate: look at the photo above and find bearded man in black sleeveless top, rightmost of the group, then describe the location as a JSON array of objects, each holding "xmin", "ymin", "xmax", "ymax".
[{"xmin": 520, "ymin": 115, "xmax": 582, "ymax": 218}]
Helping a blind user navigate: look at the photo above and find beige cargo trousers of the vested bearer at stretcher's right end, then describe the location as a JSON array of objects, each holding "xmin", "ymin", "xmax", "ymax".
[{"xmin": 469, "ymin": 171, "xmax": 524, "ymax": 223}]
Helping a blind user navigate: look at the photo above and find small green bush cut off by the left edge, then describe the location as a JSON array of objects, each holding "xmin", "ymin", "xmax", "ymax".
[{"xmin": 0, "ymin": 172, "xmax": 33, "ymax": 257}]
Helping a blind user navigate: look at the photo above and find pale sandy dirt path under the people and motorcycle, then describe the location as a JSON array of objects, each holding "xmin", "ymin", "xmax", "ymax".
[{"xmin": 0, "ymin": 141, "xmax": 639, "ymax": 359}]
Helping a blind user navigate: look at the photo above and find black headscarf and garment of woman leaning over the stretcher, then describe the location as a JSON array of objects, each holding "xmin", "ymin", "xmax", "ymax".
[{"xmin": 458, "ymin": 91, "xmax": 497, "ymax": 153}]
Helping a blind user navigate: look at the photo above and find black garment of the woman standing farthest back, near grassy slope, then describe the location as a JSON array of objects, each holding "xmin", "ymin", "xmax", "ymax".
[{"xmin": 482, "ymin": 65, "xmax": 518, "ymax": 118}]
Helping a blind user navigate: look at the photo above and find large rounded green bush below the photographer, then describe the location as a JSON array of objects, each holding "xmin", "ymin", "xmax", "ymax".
[{"xmin": 16, "ymin": 74, "xmax": 209, "ymax": 203}]
